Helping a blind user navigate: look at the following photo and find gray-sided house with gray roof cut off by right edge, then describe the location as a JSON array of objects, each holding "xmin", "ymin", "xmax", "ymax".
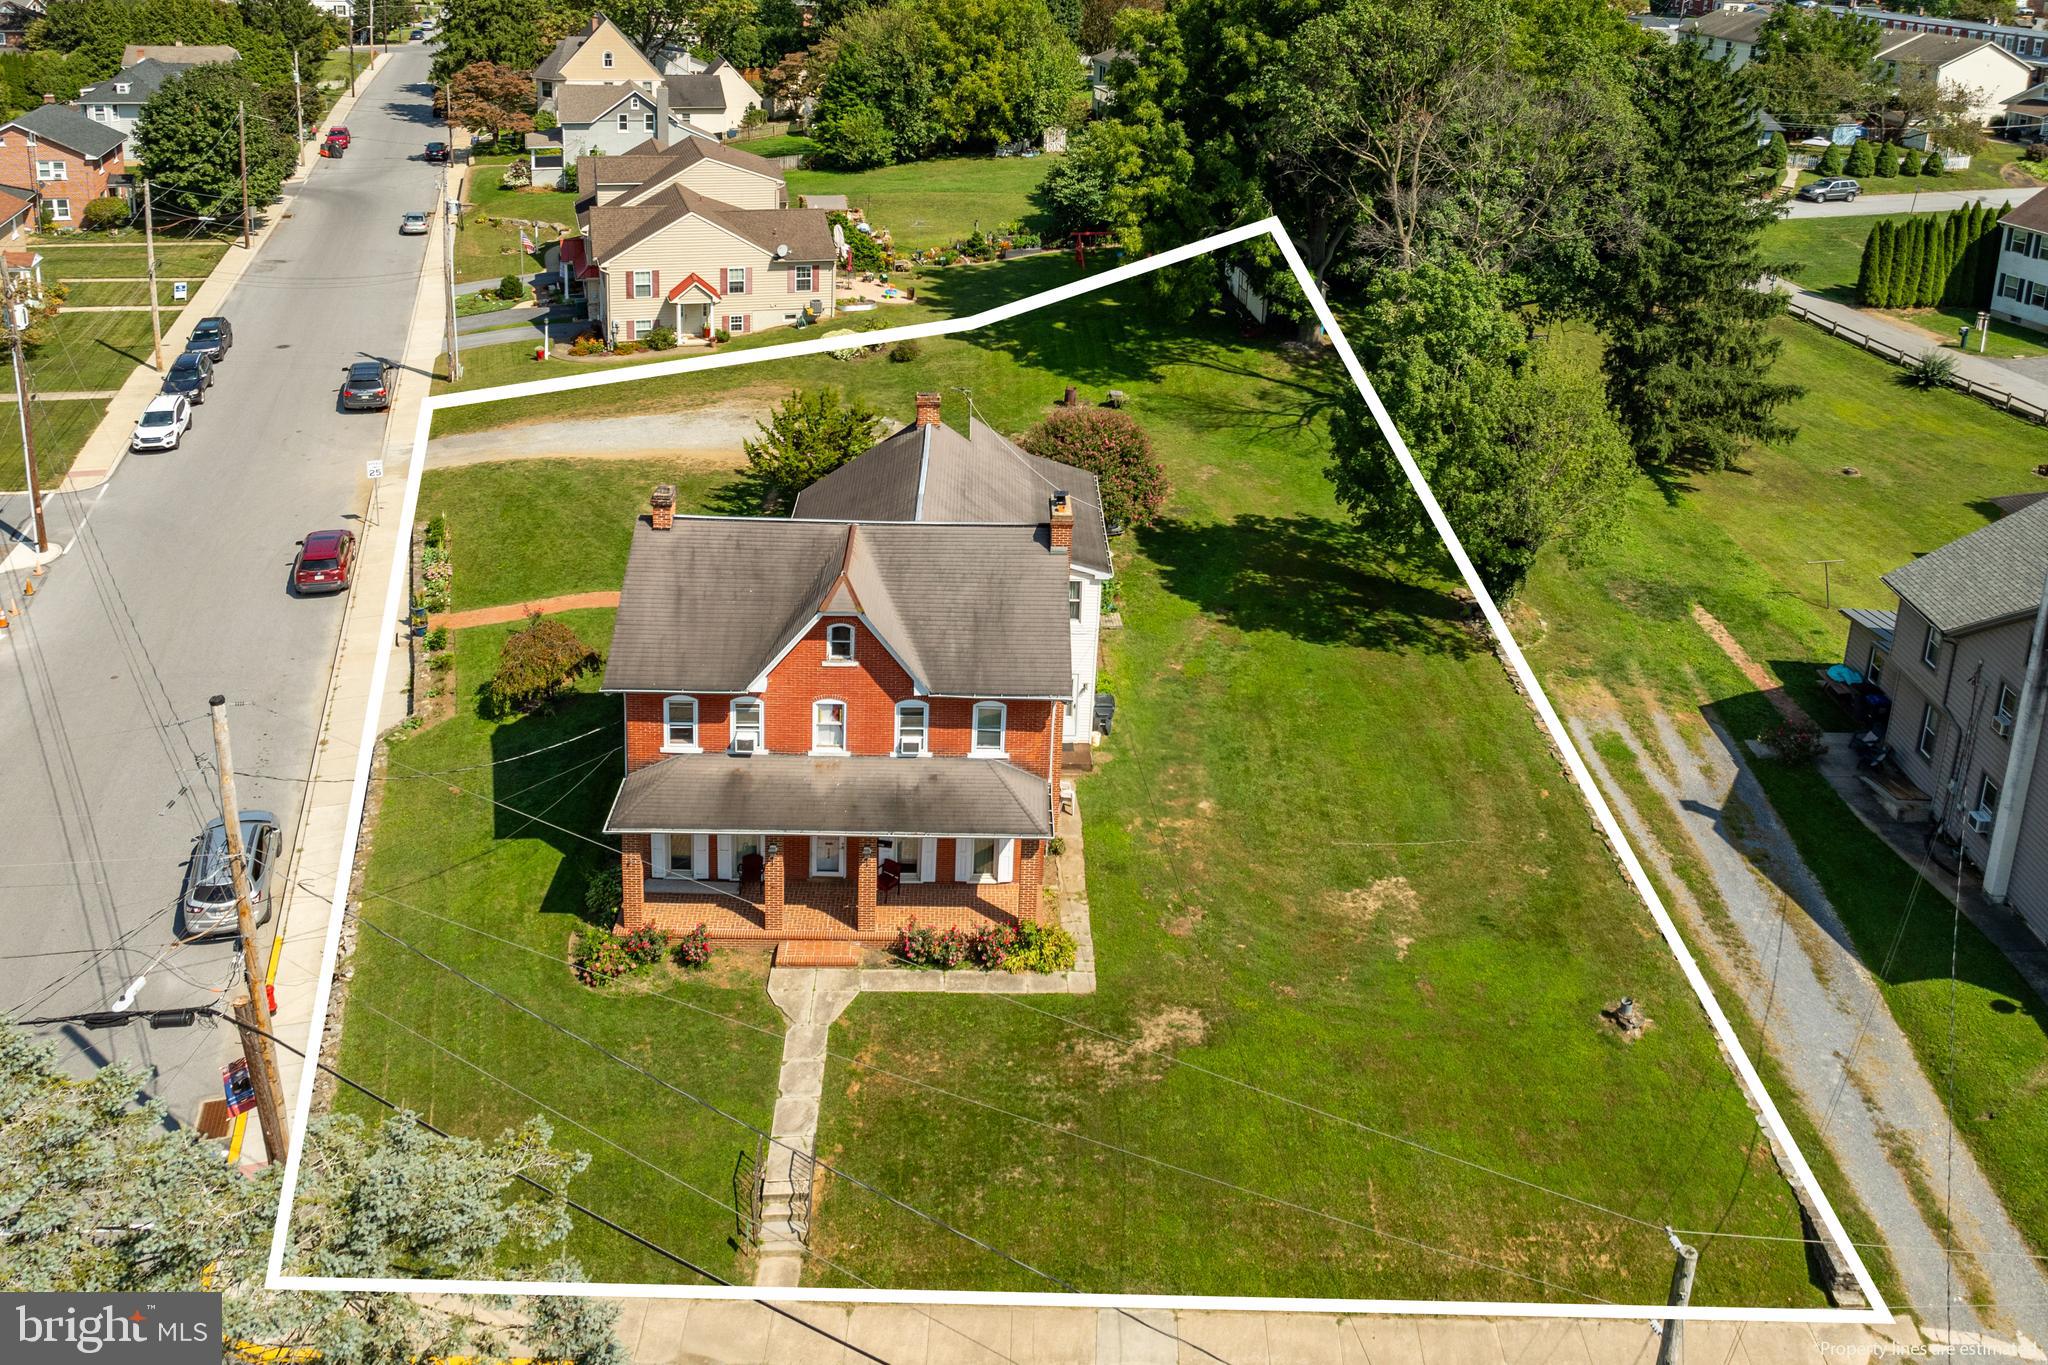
[{"xmin": 1843, "ymin": 499, "xmax": 2048, "ymax": 941}]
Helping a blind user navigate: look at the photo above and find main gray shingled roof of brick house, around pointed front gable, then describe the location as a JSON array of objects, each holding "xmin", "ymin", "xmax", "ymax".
[{"xmin": 604, "ymin": 516, "xmax": 1073, "ymax": 698}]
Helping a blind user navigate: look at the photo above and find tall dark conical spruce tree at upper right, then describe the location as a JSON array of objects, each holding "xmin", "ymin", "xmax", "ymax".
[{"xmin": 1602, "ymin": 43, "xmax": 1800, "ymax": 469}]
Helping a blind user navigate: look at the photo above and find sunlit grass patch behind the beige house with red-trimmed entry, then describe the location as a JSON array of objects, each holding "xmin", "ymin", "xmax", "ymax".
[{"xmin": 784, "ymin": 156, "xmax": 1053, "ymax": 252}]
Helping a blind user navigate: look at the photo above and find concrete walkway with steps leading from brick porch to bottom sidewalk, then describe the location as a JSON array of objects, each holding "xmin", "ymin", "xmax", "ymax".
[{"xmin": 754, "ymin": 968, "xmax": 860, "ymax": 1285}]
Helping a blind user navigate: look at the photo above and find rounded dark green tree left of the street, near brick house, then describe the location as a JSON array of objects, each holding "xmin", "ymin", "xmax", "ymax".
[{"xmin": 135, "ymin": 65, "xmax": 299, "ymax": 221}]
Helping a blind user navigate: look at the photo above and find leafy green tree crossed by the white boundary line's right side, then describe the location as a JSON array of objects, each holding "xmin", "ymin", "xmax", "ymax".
[{"xmin": 1329, "ymin": 260, "xmax": 1636, "ymax": 598}]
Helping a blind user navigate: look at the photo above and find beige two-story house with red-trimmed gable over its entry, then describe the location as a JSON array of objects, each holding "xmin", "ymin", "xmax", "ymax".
[{"xmin": 559, "ymin": 137, "xmax": 840, "ymax": 342}]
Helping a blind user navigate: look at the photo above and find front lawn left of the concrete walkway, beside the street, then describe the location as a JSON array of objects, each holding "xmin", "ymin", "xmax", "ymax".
[{"xmin": 336, "ymin": 613, "xmax": 780, "ymax": 1283}]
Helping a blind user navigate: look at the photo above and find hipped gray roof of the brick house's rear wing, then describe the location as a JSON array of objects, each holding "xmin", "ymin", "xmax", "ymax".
[{"xmin": 795, "ymin": 417, "xmax": 1110, "ymax": 573}]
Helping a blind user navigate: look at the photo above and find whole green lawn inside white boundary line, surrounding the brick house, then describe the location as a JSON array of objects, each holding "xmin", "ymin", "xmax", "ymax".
[{"xmin": 380, "ymin": 287, "xmax": 1821, "ymax": 1306}]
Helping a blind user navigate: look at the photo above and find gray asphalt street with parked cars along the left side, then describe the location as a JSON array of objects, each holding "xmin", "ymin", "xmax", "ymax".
[{"xmin": 0, "ymin": 45, "xmax": 440, "ymax": 1124}]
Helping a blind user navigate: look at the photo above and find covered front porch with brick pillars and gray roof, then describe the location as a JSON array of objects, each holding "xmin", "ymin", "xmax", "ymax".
[{"xmin": 606, "ymin": 753, "xmax": 1053, "ymax": 943}]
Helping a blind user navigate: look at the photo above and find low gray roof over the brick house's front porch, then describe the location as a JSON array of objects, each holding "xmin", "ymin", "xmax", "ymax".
[{"xmin": 604, "ymin": 753, "xmax": 1053, "ymax": 839}]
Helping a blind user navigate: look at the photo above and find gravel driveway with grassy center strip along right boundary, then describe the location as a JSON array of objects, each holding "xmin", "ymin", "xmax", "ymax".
[{"xmin": 1571, "ymin": 714, "xmax": 2048, "ymax": 1340}]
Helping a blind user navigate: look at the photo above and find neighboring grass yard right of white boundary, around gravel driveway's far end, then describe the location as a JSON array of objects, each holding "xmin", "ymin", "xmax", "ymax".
[{"xmin": 1518, "ymin": 321, "xmax": 2048, "ymax": 1252}]
